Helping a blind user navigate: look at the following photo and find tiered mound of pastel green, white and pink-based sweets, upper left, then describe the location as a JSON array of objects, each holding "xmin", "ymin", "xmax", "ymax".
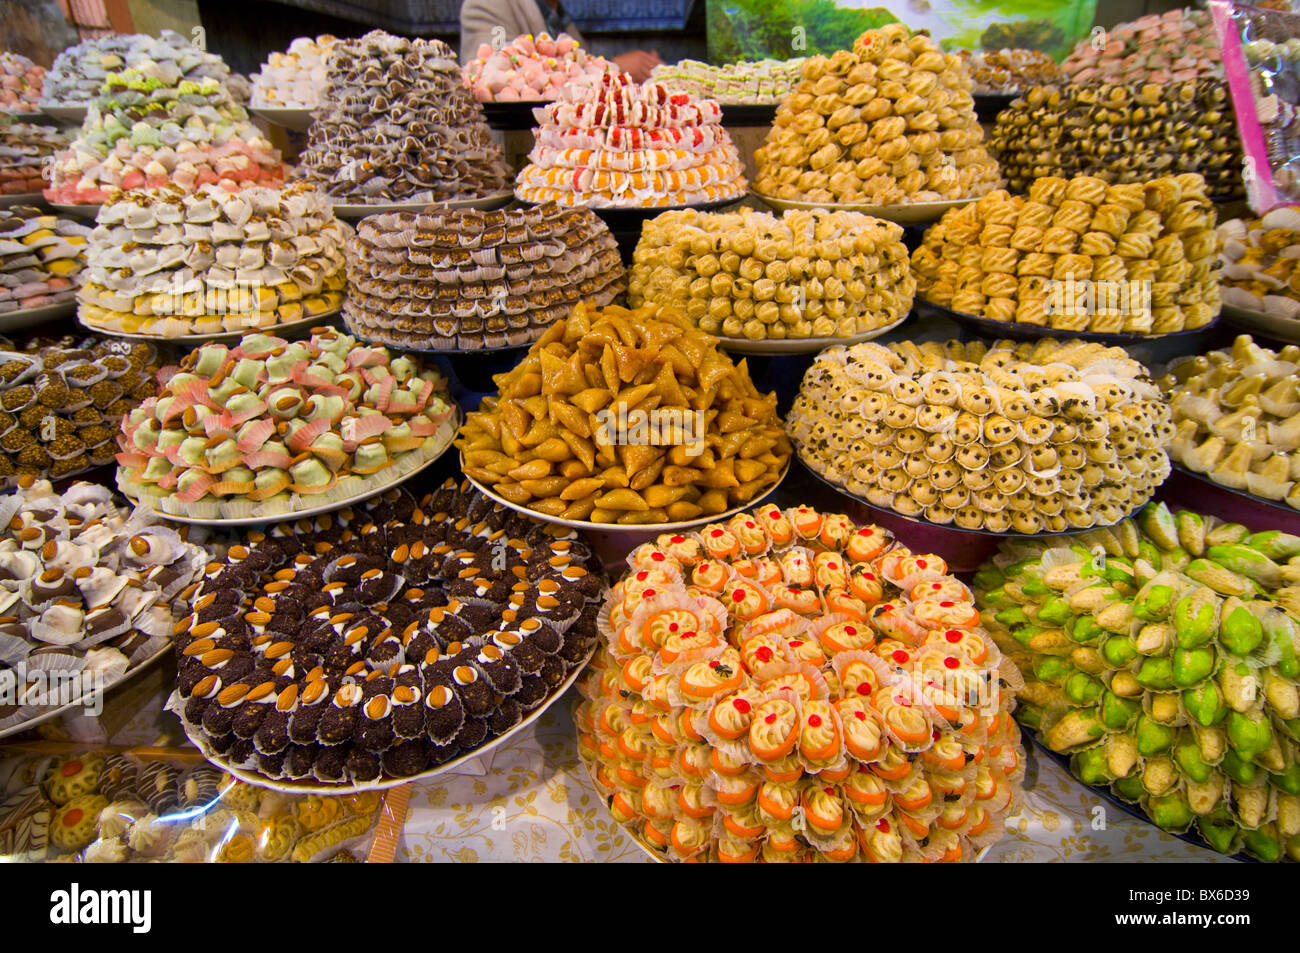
[{"xmin": 46, "ymin": 62, "xmax": 289, "ymax": 204}]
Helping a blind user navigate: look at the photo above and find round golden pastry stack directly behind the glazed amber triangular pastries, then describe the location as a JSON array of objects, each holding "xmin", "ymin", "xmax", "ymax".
[{"xmin": 628, "ymin": 208, "xmax": 917, "ymax": 341}]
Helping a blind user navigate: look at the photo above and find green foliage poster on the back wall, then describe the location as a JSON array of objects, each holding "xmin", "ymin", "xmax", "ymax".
[{"xmin": 707, "ymin": 0, "xmax": 1097, "ymax": 62}]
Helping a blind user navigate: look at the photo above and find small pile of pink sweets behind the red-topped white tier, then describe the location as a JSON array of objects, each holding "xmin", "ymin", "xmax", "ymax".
[{"xmin": 464, "ymin": 33, "xmax": 618, "ymax": 103}]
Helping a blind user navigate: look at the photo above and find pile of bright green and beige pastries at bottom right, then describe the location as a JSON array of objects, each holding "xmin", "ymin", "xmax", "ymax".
[{"xmin": 975, "ymin": 503, "xmax": 1300, "ymax": 861}]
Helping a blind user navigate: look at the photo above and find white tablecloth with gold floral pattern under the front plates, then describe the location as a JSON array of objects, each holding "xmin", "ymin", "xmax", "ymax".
[{"xmin": 398, "ymin": 696, "xmax": 1227, "ymax": 863}]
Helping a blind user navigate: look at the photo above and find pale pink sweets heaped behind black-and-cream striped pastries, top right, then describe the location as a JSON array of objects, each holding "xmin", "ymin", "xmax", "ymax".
[{"xmin": 1061, "ymin": 9, "xmax": 1223, "ymax": 83}]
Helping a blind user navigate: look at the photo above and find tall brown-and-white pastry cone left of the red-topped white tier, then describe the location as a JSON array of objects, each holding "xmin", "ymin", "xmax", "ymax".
[{"xmin": 298, "ymin": 30, "xmax": 510, "ymax": 204}]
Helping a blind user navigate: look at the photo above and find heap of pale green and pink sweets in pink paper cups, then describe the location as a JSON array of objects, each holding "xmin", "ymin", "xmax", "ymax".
[{"xmin": 117, "ymin": 328, "xmax": 455, "ymax": 519}]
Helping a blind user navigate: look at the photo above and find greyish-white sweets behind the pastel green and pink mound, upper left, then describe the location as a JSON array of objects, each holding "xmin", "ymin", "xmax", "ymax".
[{"xmin": 40, "ymin": 30, "xmax": 248, "ymax": 107}]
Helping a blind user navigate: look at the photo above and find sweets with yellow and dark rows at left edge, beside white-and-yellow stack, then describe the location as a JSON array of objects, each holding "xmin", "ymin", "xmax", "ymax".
[{"xmin": 0, "ymin": 205, "xmax": 90, "ymax": 315}]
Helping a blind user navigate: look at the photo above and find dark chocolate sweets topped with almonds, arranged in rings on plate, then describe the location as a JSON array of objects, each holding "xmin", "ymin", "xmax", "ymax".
[{"xmin": 178, "ymin": 484, "xmax": 603, "ymax": 783}]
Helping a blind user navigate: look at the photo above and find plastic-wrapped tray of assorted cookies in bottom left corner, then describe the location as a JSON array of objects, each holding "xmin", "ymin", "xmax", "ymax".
[{"xmin": 0, "ymin": 749, "xmax": 382, "ymax": 863}]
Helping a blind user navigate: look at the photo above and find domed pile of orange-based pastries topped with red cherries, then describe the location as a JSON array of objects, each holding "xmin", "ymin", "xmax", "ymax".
[{"xmin": 573, "ymin": 506, "xmax": 1024, "ymax": 863}]
